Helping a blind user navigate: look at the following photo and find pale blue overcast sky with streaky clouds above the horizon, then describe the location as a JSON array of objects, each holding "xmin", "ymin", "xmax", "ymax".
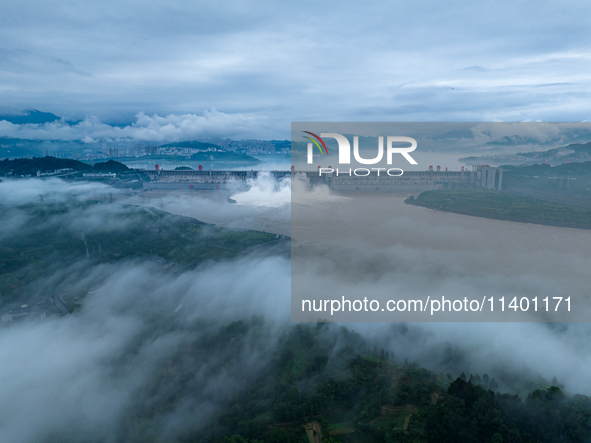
[{"xmin": 0, "ymin": 0, "xmax": 591, "ymax": 140}]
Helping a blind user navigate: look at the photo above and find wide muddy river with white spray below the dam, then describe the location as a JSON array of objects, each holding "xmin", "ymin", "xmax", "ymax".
[{"xmin": 135, "ymin": 187, "xmax": 591, "ymax": 289}]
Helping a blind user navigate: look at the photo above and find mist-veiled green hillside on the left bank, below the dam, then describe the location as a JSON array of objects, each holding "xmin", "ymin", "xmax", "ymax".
[{"xmin": 0, "ymin": 202, "xmax": 277, "ymax": 302}]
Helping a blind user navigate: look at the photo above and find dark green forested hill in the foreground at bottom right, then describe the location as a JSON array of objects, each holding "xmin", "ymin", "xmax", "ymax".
[{"xmin": 189, "ymin": 321, "xmax": 591, "ymax": 443}]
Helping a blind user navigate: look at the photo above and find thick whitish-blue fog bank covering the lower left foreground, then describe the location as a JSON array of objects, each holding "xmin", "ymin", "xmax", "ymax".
[{"xmin": 0, "ymin": 258, "xmax": 289, "ymax": 442}]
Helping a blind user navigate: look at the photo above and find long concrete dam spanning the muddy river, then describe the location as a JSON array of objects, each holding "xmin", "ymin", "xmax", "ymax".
[{"xmin": 142, "ymin": 165, "xmax": 503, "ymax": 192}]
